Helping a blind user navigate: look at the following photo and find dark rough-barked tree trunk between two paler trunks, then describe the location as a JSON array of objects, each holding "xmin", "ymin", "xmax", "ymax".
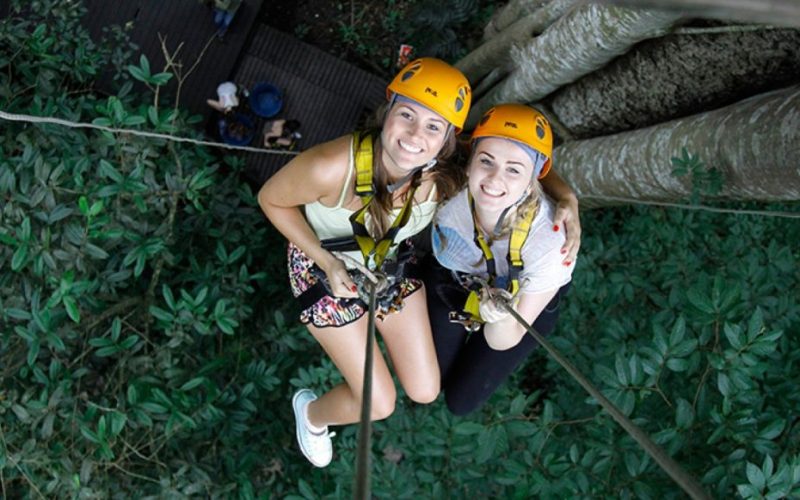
[{"xmin": 550, "ymin": 26, "xmax": 800, "ymax": 138}]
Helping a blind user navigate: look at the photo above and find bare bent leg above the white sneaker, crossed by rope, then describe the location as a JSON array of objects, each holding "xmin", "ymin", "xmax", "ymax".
[{"xmin": 308, "ymin": 315, "xmax": 396, "ymax": 427}]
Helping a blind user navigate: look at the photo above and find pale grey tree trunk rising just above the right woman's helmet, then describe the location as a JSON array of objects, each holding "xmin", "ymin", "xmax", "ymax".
[{"xmin": 467, "ymin": 4, "xmax": 678, "ymax": 127}]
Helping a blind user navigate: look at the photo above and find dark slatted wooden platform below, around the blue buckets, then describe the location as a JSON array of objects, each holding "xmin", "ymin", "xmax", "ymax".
[{"xmin": 78, "ymin": 0, "xmax": 387, "ymax": 184}]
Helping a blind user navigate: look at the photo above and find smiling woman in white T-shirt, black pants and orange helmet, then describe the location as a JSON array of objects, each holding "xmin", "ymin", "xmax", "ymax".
[{"xmin": 424, "ymin": 104, "xmax": 579, "ymax": 415}]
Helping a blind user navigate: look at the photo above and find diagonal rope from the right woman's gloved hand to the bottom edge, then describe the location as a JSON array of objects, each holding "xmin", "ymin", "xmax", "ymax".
[{"xmin": 499, "ymin": 300, "xmax": 711, "ymax": 500}]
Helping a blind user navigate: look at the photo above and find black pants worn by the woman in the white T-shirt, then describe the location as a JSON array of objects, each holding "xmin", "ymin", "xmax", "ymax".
[{"xmin": 423, "ymin": 256, "xmax": 570, "ymax": 415}]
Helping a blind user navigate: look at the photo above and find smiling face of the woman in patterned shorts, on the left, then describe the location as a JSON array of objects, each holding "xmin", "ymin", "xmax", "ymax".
[{"xmin": 381, "ymin": 99, "xmax": 448, "ymax": 177}]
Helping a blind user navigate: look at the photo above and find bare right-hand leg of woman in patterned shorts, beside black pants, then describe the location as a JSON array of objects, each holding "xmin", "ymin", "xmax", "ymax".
[{"xmin": 378, "ymin": 287, "xmax": 440, "ymax": 403}]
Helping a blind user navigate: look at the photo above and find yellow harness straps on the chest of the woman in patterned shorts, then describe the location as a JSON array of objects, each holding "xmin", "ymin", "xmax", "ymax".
[{"xmin": 350, "ymin": 132, "xmax": 422, "ymax": 271}]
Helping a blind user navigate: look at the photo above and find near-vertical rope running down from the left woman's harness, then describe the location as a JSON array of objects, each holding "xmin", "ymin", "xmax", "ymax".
[{"xmin": 353, "ymin": 280, "xmax": 376, "ymax": 500}]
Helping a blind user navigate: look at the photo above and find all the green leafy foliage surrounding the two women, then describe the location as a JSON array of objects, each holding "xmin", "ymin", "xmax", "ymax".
[{"xmin": 0, "ymin": 0, "xmax": 800, "ymax": 498}]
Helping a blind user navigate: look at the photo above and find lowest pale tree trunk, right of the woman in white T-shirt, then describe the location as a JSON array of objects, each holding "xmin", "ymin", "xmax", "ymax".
[{"xmin": 554, "ymin": 85, "xmax": 800, "ymax": 207}]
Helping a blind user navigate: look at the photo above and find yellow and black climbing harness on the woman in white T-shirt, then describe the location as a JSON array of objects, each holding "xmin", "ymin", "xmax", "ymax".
[{"xmin": 450, "ymin": 193, "xmax": 537, "ymax": 332}]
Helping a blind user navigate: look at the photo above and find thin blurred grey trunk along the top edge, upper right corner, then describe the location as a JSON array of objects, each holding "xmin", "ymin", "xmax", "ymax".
[{"xmin": 604, "ymin": 0, "xmax": 800, "ymax": 27}]
